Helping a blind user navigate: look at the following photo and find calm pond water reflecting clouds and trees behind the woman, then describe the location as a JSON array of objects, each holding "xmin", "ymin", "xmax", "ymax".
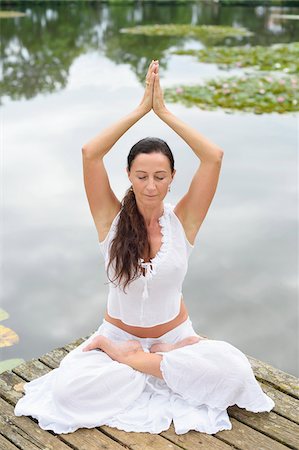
[{"xmin": 1, "ymin": 3, "xmax": 299, "ymax": 376}]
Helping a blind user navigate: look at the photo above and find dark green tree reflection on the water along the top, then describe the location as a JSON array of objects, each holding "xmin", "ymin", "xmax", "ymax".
[{"xmin": 0, "ymin": 2, "xmax": 298, "ymax": 100}]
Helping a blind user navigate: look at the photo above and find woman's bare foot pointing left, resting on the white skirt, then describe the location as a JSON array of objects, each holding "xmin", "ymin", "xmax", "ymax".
[{"xmin": 83, "ymin": 335, "xmax": 143, "ymax": 362}]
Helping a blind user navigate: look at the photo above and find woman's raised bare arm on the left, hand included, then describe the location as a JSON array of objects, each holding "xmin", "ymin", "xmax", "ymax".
[{"xmin": 82, "ymin": 61, "xmax": 157, "ymax": 241}]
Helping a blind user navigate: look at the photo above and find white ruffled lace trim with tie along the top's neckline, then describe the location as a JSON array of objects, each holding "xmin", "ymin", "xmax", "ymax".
[{"xmin": 139, "ymin": 203, "xmax": 172, "ymax": 300}]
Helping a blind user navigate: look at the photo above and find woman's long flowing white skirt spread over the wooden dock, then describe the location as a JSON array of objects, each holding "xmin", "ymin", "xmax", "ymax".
[{"xmin": 14, "ymin": 317, "xmax": 275, "ymax": 434}]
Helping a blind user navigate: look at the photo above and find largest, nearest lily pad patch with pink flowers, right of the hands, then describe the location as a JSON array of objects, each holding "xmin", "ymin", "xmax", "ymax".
[{"xmin": 164, "ymin": 73, "xmax": 299, "ymax": 114}]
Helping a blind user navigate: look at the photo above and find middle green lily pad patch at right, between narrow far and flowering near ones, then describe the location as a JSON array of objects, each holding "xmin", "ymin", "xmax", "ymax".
[{"xmin": 173, "ymin": 42, "xmax": 299, "ymax": 73}]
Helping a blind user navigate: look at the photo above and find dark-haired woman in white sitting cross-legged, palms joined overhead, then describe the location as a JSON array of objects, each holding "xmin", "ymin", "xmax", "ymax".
[{"xmin": 15, "ymin": 61, "xmax": 275, "ymax": 434}]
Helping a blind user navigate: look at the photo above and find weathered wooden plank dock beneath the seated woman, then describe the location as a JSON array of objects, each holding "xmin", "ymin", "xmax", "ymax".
[{"xmin": 0, "ymin": 336, "xmax": 299, "ymax": 450}]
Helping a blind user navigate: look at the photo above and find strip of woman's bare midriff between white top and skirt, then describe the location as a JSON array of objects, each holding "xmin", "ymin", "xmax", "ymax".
[{"xmin": 104, "ymin": 297, "xmax": 188, "ymax": 338}]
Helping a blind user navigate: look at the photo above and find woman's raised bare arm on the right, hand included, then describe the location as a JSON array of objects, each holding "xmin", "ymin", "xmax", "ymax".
[{"xmin": 153, "ymin": 61, "xmax": 223, "ymax": 244}]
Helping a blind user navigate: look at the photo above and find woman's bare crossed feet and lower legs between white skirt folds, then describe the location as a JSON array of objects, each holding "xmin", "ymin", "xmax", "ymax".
[{"xmin": 83, "ymin": 335, "xmax": 204, "ymax": 379}]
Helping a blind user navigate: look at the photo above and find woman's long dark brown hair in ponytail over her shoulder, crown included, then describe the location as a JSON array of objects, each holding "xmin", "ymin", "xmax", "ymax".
[{"xmin": 107, "ymin": 137, "xmax": 174, "ymax": 292}]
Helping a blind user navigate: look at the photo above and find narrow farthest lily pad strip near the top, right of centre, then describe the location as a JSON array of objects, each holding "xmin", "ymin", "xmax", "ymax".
[{"xmin": 120, "ymin": 24, "xmax": 253, "ymax": 45}]
